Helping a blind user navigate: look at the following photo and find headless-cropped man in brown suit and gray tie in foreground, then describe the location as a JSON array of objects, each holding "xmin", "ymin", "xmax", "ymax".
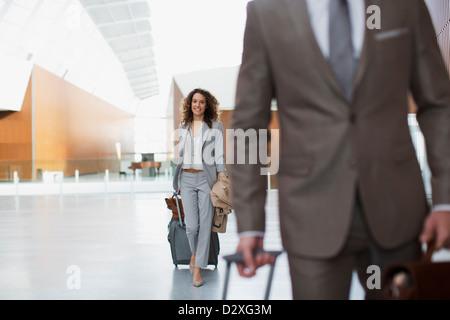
[{"xmin": 231, "ymin": 0, "xmax": 450, "ymax": 299}]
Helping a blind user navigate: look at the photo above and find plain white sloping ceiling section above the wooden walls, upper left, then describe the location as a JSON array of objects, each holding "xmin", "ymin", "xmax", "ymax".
[{"xmin": 0, "ymin": 0, "xmax": 145, "ymax": 114}]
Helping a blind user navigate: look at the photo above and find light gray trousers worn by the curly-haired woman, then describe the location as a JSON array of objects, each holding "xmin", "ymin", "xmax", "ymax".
[{"xmin": 180, "ymin": 171, "xmax": 214, "ymax": 268}]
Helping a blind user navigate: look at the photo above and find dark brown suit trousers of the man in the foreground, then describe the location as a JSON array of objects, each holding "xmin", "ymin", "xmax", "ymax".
[{"xmin": 288, "ymin": 195, "xmax": 422, "ymax": 300}]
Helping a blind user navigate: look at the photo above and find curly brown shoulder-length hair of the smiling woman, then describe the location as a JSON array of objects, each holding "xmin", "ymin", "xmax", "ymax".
[{"xmin": 181, "ymin": 89, "xmax": 220, "ymax": 128}]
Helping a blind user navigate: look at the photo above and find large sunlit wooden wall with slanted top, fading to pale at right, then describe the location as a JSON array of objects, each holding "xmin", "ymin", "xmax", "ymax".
[{"xmin": 34, "ymin": 67, "xmax": 134, "ymax": 176}]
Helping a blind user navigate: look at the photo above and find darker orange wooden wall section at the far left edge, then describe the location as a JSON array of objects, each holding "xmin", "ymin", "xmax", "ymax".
[{"xmin": 0, "ymin": 75, "xmax": 32, "ymax": 181}]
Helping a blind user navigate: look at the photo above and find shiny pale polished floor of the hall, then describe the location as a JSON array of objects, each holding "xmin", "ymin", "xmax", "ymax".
[{"xmin": 0, "ymin": 188, "xmax": 446, "ymax": 300}]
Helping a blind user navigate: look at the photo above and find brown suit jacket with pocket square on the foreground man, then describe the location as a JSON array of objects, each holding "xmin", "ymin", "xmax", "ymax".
[{"xmin": 230, "ymin": 0, "xmax": 450, "ymax": 257}]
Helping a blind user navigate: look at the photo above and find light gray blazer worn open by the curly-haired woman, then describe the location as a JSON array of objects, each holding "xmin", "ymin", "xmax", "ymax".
[{"xmin": 173, "ymin": 121, "xmax": 226, "ymax": 190}]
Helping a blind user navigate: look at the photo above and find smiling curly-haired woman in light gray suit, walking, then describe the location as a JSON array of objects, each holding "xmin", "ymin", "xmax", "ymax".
[{"xmin": 173, "ymin": 89, "xmax": 226, "ymax": 287}]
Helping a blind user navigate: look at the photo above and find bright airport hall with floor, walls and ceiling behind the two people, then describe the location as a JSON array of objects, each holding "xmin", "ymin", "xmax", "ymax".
[{"xmin": 0, "ymin": 0, "xmax": 450, "ymax": 300}]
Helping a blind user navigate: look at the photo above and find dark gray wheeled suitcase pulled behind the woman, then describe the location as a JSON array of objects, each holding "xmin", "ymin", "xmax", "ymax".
[{"xmin": 167, "ymin": 193, "xmax": 220, "ymax": 267}]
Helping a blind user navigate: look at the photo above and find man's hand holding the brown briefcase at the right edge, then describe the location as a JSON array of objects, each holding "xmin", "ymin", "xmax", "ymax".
[{"xmin": 420, "ymin": 211, "xmax": 450, "ymax": 251}]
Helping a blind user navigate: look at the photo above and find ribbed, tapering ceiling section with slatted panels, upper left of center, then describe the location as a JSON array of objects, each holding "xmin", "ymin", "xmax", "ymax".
[{"xmin": 80, "ymin": 0, "xmax": 159, "ymax": 100}]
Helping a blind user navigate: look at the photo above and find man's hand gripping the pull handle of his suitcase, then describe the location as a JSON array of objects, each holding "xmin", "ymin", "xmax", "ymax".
[{"xmin": 236, "ymin": 236, "xmax": 276, "ymax": 278}]
